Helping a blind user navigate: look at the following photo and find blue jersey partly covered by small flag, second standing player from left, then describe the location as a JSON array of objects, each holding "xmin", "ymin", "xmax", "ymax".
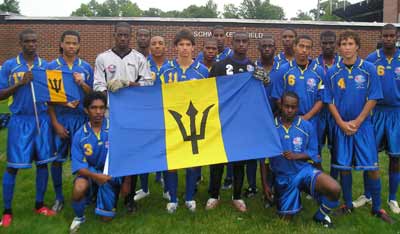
[{"xmin": 46, "ymin": 56, "xmax": 93, "ymax": 115}]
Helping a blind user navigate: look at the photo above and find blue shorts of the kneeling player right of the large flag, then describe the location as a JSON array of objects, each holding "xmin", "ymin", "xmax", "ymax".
[{"xmin": 274, "ymin": 165, "xmax": 322, "ymax": 215}]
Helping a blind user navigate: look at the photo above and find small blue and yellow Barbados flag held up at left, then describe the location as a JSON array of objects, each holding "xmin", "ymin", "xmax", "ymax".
[{"xmin": 32, "ymin": 68, "xmax": 80, "ymax": 103}]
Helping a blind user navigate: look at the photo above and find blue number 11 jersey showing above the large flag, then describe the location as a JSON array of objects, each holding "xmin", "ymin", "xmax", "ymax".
[{"xmin": 160, "ymin": 60, "xmax": 208, "ymax": 83}]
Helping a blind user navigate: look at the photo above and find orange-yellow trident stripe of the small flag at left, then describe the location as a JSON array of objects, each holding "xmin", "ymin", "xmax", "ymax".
[{"xmin": 46, "ymin": 70, "xmax": 67, "ymax": 102}]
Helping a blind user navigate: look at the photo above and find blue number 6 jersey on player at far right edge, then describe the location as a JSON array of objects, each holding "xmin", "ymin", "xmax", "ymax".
[{"xmin": 366, "ymin": 49, "xmax": 400, "ymax": 108}]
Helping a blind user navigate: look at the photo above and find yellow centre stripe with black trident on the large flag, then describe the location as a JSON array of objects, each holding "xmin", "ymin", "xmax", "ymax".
[{"xmin": 162, "ymin": 78, "xmax": 228, "ymax": 170}]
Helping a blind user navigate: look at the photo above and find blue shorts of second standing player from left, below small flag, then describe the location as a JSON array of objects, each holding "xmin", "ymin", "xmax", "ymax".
[{"xmin": 54, "ymin": 114, "xmax": 87, "ymax": 162}]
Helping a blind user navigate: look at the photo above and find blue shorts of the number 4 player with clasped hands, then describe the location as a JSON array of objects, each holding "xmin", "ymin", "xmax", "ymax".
[{"xmin": 332, "ymin": 119, "xmax": 379, "ymax": 171}]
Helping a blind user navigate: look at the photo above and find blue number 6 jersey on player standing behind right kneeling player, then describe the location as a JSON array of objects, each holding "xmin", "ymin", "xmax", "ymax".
[{"xmin": 271, "ymin": 61, "xmax": 324, "ymax": 115}]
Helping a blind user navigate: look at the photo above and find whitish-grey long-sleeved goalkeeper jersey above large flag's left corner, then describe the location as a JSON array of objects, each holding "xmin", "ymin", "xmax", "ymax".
[{"xmin": 93, "ymin": 49, "xmax": 154, "ymax": 91}]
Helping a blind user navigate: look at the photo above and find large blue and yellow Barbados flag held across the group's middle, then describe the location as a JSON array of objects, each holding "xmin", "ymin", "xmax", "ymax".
[{"xmin": 108, "ymin": 73, "xmax": 282, "ymax": 176}]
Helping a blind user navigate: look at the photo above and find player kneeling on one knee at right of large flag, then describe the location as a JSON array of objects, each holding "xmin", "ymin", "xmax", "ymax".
[{"xmin": 263, "ymin": 92, "xmax": 341, "ymax": 227}]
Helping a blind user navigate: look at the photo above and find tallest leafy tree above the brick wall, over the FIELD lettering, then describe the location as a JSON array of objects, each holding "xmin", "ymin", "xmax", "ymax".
[{"xmin": 239, "ymin": 0, "xmax": 285, "ymax": 19}]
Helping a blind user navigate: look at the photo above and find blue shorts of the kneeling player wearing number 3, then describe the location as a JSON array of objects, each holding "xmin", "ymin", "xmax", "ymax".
[{"xmin": 77, "ymin": 169, "xmax": 122, "ymax": 217}]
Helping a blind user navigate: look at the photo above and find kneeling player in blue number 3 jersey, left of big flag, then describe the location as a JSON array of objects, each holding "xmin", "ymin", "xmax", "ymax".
[{"xmin": 70, "ymin": 92, "xmax": 121, "ymax": 232}]
